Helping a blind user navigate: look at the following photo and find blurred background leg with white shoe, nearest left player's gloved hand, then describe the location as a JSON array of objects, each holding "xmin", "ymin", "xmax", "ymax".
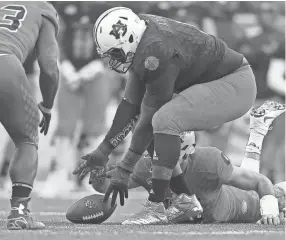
[{"xmin": 40, "ymin": 76, "xmax": 82, "ymax": 198}]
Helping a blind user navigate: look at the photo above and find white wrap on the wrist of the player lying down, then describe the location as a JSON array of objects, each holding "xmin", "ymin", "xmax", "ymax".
[{"xmin": 260, "ymin": 195, "xmax": 279, "ymax": 216}]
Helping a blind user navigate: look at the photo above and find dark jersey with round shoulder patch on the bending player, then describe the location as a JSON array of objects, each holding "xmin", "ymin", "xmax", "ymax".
[{"xmin": 132, "ymin": 14, "xmax": 243, "ymax": 92}]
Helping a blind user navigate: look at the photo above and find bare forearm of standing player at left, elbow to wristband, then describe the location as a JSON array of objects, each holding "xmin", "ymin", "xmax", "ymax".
[{"xmin": 39, "ymin": 67, "xmax": 59, "ymax": 109}]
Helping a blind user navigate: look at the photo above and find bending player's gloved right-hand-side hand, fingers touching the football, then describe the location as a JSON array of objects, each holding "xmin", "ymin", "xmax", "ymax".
[{"xmin": 103, "ymin": 167, "xmax": 131, "ymax": 207}]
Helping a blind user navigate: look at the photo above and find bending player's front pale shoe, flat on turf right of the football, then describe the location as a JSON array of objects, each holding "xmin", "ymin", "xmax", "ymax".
[{"xmin": 122, "ymin": 200, "xmax": 168, "ymax": 225}]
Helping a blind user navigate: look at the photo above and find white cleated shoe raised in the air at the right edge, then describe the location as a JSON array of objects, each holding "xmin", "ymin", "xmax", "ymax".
[{"xmin": 250, "ymin": 100, "xmax": 285, "ymax": 135}]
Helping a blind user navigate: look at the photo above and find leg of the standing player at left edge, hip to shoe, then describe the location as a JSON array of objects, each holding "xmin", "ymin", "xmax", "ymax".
[{"xmin": 0, "ymin": 55, "xmax": 44, "ymax": 230}]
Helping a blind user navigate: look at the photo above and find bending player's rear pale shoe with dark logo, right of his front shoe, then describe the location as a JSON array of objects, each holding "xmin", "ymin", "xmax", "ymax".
[{"xmin": 166, "ymin": 193, "xmax": 203, "ymax": 224}]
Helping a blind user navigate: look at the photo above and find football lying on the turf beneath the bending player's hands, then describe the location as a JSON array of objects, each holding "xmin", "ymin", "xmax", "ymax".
[{"xmin": 66, "ymin": 194, "xmax": 117, "ymax": 224}]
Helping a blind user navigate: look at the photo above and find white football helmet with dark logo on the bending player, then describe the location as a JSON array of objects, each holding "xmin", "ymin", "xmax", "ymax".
[{"xmin": 93, "ymin": 7, "xmax": 146, "ymax": 73}]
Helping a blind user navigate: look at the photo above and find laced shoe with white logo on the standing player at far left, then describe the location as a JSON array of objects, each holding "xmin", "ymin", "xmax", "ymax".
[{"xmin": 7, "ymin": 198, "xmax": 45, "ymax": 230}]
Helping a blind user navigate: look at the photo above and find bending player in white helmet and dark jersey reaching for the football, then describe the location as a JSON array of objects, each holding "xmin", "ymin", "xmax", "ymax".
[{"xmin": 74, "ymin": 7, "xmax": 256, "ymax": 224}]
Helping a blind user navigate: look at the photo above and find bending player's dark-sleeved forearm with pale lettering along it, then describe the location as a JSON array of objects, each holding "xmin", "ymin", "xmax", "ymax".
[{"xmin": 99, "ymin": 99, "xmax": 140, "ymax": 155}]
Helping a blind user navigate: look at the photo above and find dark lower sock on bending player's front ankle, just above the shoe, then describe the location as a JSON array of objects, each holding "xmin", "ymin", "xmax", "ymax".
[{"xmin": 148, "ymin": 178, "xmax": 169, "ymax": 203}]
